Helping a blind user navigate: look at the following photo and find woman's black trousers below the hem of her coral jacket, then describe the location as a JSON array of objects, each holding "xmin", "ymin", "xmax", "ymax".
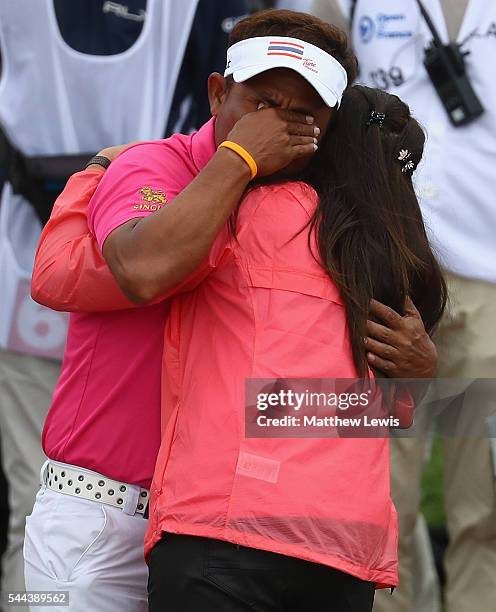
[{"xmin": 148, "ymin": 533, "xmax": 374, "ymax": 612}]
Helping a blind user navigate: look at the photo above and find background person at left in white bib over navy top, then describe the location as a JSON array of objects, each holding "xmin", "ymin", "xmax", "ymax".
[{"xmin": 0, "ymin": 0, "xmax": 252, "ymax": 604}]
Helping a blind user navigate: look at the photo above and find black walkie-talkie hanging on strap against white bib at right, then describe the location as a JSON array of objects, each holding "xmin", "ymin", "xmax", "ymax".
[{"xmin": 417, "ymin": 0, "xmax": 484, "ymax": 127}]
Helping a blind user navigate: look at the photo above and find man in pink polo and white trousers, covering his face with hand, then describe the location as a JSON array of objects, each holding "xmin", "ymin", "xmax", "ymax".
[{"xmin": 26, "ymin": 8, "xmax": 435, "ymax": 610}]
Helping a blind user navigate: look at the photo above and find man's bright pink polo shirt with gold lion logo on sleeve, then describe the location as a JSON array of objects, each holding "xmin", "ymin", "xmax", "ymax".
[{"xmin": 43, "ymin": 120, "xmax": 215, "ymax": 488}]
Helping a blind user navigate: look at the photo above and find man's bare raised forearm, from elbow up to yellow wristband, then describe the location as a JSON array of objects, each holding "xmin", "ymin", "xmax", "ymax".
[{"xmin": 103, "ymin": 149, "xmax": 251, "ymax": 303}]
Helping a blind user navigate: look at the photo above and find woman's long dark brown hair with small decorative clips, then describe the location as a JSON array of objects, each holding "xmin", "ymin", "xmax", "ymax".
[{"xmin": 304, "ymin": 85, "xmax": 447, "ymax": 376}]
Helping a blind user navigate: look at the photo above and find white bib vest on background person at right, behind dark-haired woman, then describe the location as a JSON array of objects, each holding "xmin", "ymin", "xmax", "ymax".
[{"xmin": 346, "ymin": 0, "xmax": 496, "ymax": 282}]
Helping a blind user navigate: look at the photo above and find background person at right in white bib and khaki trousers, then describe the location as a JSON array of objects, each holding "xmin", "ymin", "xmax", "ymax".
[{"xmin": 312, "ymin": 0, "xmax": 496, "ymax": 612}]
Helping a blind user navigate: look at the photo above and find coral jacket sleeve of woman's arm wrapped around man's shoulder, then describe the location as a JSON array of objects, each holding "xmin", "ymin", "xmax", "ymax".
[{"xmin": 31, "ymin": 169, "xmax": 136, "ymax": 312}]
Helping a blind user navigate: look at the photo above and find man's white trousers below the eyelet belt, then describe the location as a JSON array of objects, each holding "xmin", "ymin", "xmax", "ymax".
[{"xmin": 24, "ymin": 478, "xmax": 148, "ymax": 612}]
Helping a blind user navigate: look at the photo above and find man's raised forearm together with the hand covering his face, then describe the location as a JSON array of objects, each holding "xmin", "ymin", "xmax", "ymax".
[{"xmin": 103, "ymin": 109, "xmax": 320, "ymax": 303}]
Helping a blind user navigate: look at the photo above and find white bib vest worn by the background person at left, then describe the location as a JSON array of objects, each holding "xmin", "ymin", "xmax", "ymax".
[{"xmin": 0, "ymin": 0, "xmax": 198, "ymax": 358}]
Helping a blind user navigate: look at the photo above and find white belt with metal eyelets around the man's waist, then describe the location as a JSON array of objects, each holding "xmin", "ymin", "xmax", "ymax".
[{"xmin": 41, "ymin": 459, "xmax": 150, "ymax": 515}]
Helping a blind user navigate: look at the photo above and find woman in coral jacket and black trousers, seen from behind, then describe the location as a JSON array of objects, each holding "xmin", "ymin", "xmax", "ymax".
[{"xmin": 146, "ymin": 86, "xmax": 446, "ymax": 612}]
